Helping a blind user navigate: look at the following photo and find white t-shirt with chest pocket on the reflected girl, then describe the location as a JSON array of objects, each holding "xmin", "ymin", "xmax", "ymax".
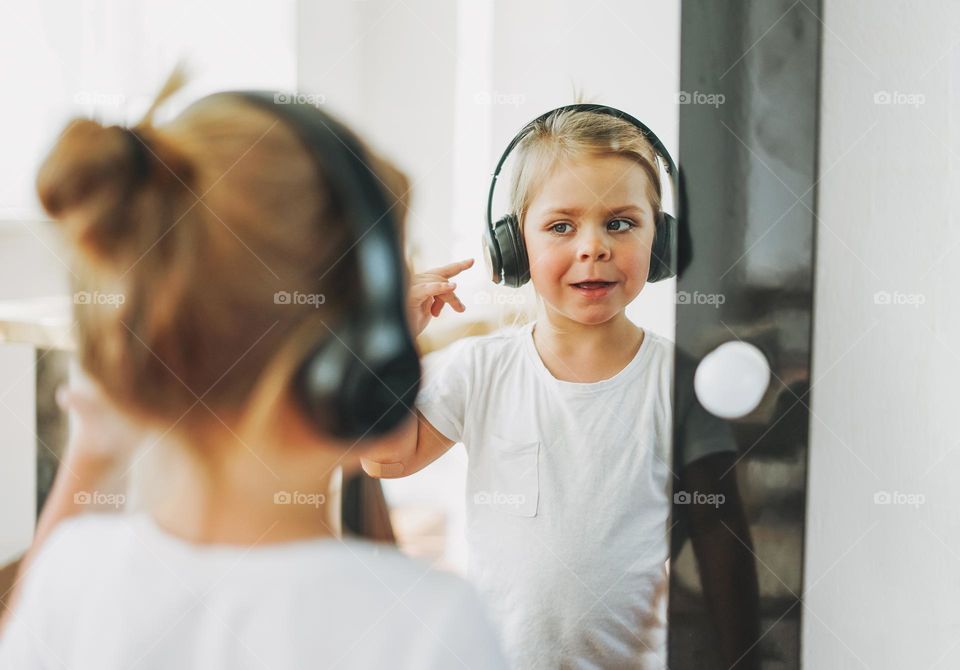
[{"xmin": 417, "ymin": 323, "xmax": 735, "ymax": 669}]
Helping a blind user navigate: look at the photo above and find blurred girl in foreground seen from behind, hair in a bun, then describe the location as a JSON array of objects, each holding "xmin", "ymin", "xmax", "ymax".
[{"xmin": 0, "ymin": 71, "xmax": 502, "ymax": 670}]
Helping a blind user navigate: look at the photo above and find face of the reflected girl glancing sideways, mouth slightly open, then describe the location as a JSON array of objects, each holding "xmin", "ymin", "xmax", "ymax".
[{"xmin": 523, "ymin": 156, "xmax": 654, "ymax": 324}]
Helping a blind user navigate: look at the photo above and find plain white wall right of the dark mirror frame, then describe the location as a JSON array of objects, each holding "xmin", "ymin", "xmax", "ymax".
[{"xmin": 803, "ymin": 0, "xmax": 960, "ymax": 670}]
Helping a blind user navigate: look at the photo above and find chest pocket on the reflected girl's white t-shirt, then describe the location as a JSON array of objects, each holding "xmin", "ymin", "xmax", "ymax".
[{"xmin": 488, "ymin": 436, "xmax": 540, "ymax": 516}]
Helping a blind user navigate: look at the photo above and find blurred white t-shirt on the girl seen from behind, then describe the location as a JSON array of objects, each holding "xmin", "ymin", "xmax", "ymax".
[{"xmin": 0, "ymin": 514, "xmax": 505, "ymax": 670}]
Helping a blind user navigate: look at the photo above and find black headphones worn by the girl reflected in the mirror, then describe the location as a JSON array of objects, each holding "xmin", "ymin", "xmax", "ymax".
[{"xmin": 484, "ymin": 104, "xmax": 683, "ymax": 288}]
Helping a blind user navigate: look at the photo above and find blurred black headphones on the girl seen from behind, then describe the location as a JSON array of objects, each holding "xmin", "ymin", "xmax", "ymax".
[{"xmin": 214, "ymin": 91, "xmax": 420, "ymax": 439}]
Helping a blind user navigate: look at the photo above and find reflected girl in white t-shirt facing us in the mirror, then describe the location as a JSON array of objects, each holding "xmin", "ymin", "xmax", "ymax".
[{"xmin": 363, "ymin": 110, "xmax": 732, "ymax": 668}]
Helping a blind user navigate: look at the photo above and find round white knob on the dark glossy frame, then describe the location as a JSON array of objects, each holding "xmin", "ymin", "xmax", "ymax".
[{"xmin": 693, "ymin": 341, "xmax": 770, "ymax": 419}]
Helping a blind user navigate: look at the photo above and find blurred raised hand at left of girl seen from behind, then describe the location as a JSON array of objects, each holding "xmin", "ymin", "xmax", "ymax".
[{"xmin": 56, "ymin": 374, "xmax": 147, "ymax": 466}]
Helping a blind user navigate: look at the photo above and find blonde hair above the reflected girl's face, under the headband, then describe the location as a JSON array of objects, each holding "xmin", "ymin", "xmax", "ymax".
[{"xmin": 510, "ymin": 110, "xmax": 662, "ymax": 230}]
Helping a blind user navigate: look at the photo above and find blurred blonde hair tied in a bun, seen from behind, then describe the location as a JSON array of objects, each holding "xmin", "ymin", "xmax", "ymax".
[{"xmin": 36, "ymin": 69, "xmax": 409, "ymax": 440}]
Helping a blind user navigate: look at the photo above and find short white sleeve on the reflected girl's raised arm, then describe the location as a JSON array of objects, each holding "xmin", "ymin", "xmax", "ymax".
[{"xmin": 416, "ymin": 338, "xmax": 476, "ymax": 442}]
